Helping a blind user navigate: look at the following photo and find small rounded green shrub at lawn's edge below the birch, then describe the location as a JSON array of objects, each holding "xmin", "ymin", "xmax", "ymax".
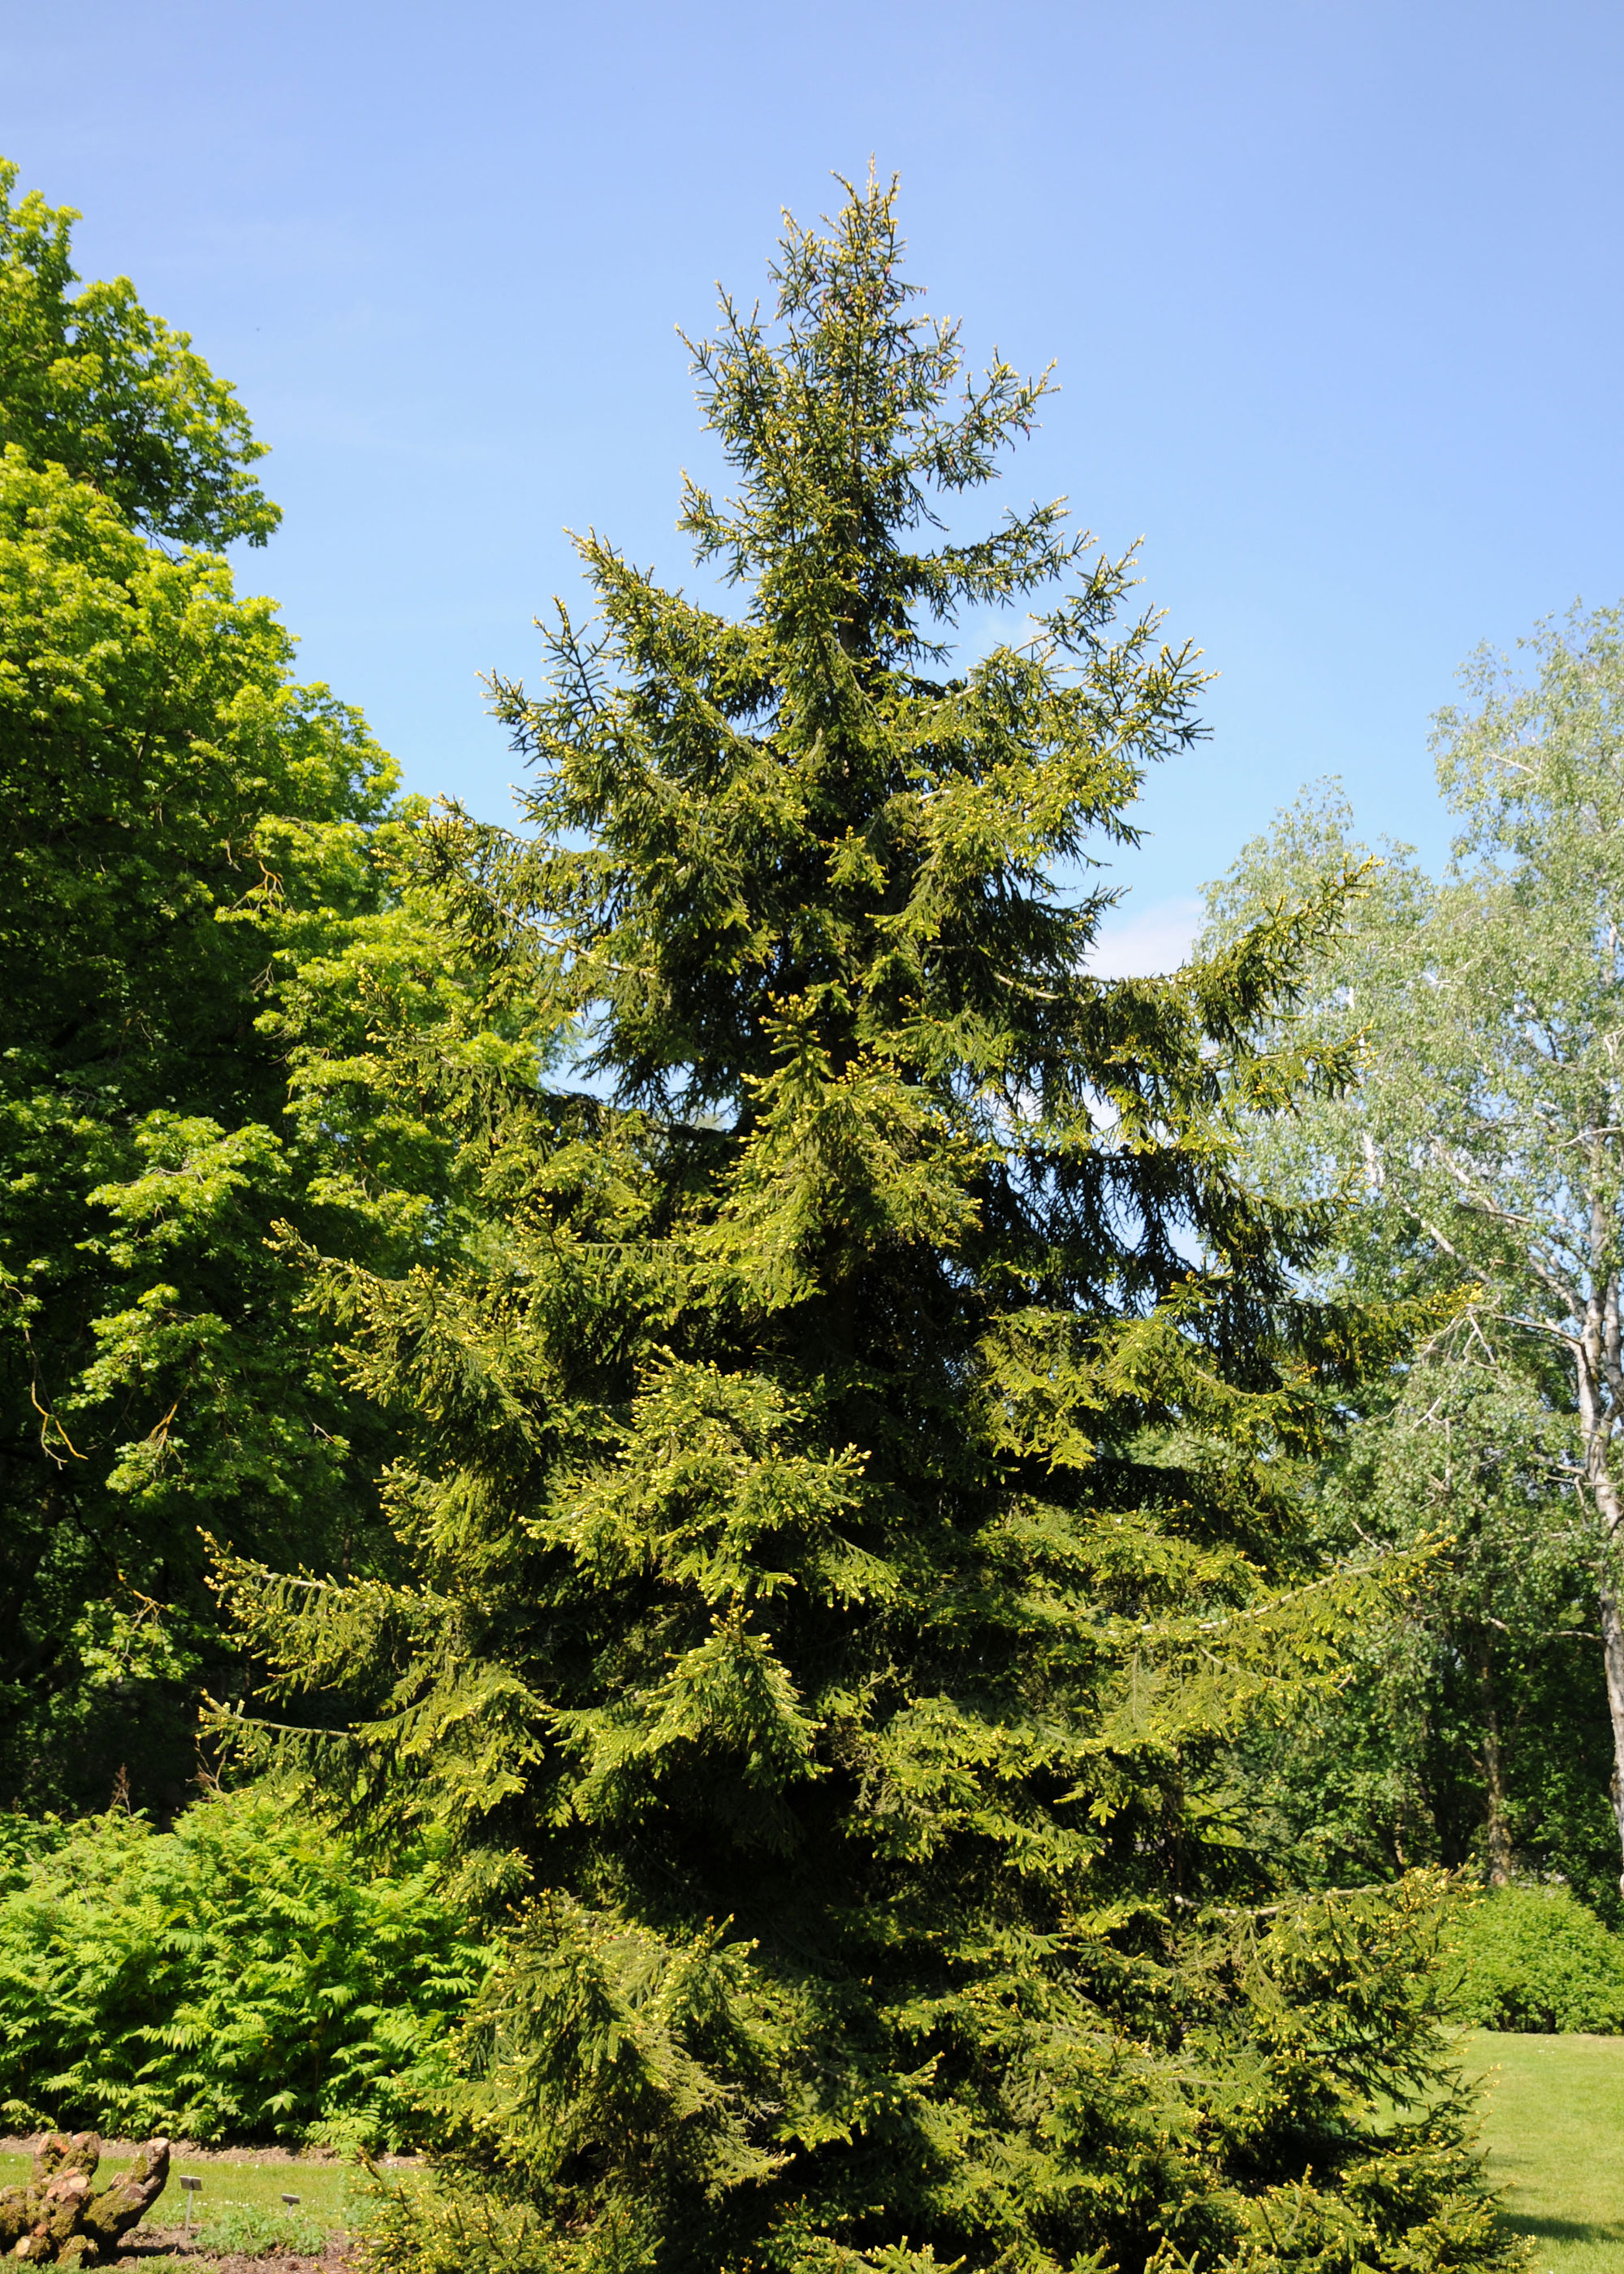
[{"xmin": 1458, "ymin": 1887, "xmax": 1624, "ymax": 2033}]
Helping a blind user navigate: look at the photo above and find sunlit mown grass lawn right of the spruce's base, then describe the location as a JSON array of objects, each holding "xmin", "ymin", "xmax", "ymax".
[{"xmin": 1467, "ymin": 2030, "xmax": 1624, "ymax": 2274}]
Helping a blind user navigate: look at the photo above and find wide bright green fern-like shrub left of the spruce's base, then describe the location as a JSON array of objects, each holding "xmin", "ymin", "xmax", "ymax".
[{"xmin": 0, "ymin": 1790, "xmax": 486, "ymax": 2149}]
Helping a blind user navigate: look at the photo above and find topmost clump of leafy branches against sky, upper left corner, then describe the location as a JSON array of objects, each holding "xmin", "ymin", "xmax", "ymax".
[{"xmin": 0, "ymin": 159, "xmax": 282, "ymax": 546}]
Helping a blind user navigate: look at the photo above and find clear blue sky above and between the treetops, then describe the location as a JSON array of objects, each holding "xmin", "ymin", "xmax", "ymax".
[{"xmin": 0, "ymin": 0, "xmax": 1624, "ymax": 964}]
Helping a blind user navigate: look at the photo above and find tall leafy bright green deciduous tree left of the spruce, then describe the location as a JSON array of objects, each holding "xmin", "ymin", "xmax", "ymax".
[{"xmin": 0, "ymin": 151, "xmax": 493, "ymax": 1808}]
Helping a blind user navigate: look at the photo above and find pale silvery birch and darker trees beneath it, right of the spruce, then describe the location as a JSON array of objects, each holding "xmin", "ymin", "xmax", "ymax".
[{"xmin": 1207, "ymin": 659, "xmax": 1624, "ymax": 1919}]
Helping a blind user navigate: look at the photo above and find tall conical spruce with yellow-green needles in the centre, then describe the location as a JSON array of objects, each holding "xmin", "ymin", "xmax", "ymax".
[{"xmin": 227, "ymin": 184, "xmax": 1501, "ymax": 2274}]
